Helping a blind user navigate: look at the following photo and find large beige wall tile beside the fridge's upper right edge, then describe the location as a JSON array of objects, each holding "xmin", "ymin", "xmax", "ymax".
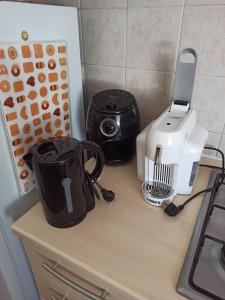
[{"xmin": 82, "ymin": 8, "xmax": 126, "ymax": 66}]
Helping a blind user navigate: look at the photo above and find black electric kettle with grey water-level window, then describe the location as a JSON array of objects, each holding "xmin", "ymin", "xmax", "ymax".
[{"xmin": 23, "ymin": 137, "xmax": 104, "ymax": 227}]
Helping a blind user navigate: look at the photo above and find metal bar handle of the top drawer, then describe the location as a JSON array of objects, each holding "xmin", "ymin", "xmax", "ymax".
[{"xmin": 41, "ymin": 262, "xmax": 108, "ymax": 300}]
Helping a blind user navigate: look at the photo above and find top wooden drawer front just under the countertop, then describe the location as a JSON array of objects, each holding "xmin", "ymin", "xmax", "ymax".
[{"xmin": 23, "ymin": 241, "xmax": 135, "ymax": 300}]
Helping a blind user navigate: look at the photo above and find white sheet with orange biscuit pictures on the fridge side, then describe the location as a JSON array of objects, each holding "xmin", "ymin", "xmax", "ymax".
[{"xmin": 0, "ymin": 42, "xmax": 71, "ymax": 195}]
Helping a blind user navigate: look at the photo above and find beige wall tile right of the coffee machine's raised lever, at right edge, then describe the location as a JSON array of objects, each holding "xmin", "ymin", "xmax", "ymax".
[{"xmin": 192, "ymin": 76, "xmax": 225, "ymax": 133}]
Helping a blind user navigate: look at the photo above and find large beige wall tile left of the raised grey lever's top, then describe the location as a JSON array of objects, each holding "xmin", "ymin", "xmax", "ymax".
[{"xmin": 127, "ymin": 7, "xmax": 183, "ymax": 71}]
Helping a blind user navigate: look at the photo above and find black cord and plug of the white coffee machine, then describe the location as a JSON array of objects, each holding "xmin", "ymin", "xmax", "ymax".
[{"xmin": 164, "ymin": 146, "xmax": 225, "ymax": 217}]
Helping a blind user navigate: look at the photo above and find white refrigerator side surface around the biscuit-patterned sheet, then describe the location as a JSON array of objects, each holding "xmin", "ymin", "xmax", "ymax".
[{"xmin": 0, "ymin": 1, "xmax": 85, "ymax": 300}]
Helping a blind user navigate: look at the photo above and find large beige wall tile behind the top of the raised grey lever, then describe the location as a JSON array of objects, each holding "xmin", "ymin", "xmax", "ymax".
[{"xmin": 180, "ymin": 6, "xmax": 225, "ymax": 76}]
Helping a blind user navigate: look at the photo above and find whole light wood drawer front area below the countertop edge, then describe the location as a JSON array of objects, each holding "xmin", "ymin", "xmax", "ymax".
[{"xmin": 23, "ymin": 241, "xmax": 135, "ymax": 300}]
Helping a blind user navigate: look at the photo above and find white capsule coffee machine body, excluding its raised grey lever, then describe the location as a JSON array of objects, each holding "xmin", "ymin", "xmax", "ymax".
[{"xmin": 137, "ymin": 103, "xmax": 208, "ymax": 206}]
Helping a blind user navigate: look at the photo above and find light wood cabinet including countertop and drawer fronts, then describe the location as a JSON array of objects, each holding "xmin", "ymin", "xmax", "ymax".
[{"xmin": 12, "ymin": 160, "xmax": 215, "ymax": 300}]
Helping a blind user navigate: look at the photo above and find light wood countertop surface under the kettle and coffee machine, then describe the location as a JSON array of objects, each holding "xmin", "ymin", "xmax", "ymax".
[{"xmin": 13, "ymin": 159, "xmax": 216, "ymax": 300}]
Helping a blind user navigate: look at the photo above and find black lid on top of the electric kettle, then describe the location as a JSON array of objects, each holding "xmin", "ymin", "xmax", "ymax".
[{"xmin": 31, "ymin": 136, "xmax": 82, "ymax": 164}]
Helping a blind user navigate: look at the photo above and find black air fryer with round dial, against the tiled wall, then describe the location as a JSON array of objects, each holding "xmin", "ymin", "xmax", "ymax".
[{"xmin": 86, "ymin": 89, "xmax": 140, "ymax": 164}]
